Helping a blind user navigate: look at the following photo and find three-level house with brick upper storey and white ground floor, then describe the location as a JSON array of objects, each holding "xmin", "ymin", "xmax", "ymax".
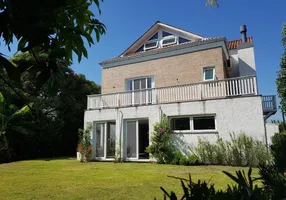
[{"xmin": 84, "ymin": 21, "xmax": 277, "ymax": 161}]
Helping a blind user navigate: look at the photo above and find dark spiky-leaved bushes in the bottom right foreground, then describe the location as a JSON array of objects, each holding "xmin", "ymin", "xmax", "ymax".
[{"xmin": 160, "ymin": 165, "xmax": 286, "ymax": 200}]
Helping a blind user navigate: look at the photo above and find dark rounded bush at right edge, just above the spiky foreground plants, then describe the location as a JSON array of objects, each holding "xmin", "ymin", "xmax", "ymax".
[{"xmin": 271, "ymin": 131, "xmax": 286, "ymax": 172}]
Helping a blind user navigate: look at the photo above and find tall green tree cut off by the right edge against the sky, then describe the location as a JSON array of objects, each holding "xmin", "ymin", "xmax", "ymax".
[{"xmin": 276, "ymin": 23, "xmax": 286, "ymax": 113}]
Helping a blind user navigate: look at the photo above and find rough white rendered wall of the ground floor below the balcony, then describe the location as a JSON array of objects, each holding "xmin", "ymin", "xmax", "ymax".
[{"xmin": 84, "ymin": 96, "xmax": 265, "ymax": 158}]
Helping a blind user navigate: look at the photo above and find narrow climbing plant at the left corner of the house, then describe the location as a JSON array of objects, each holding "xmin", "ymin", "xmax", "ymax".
[{"xmin": 77, "ymin": 123, "xmax": 92, "ymax": 162}]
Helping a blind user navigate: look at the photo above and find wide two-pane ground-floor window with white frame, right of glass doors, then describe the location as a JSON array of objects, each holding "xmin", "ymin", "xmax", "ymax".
[{"xmin": 171, "ymin": 115, "xmax": 216, "ymax": 132}]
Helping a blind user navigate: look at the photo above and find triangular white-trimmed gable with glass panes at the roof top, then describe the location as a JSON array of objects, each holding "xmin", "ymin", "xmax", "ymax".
[{"xmin": 120, "ymin": 22, "xmax": 203, "ymax": 57}]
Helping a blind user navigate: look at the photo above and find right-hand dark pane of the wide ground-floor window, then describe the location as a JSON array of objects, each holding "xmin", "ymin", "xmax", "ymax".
[{"xmin": 193, "ymin": 116, "xmax": 215, "ymax": 130}]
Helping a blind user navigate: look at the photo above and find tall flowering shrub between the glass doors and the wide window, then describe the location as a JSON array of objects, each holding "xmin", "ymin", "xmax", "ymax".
[{"xmin": 146, "ymin": 114, "xmax": 176, "ymax": 164}]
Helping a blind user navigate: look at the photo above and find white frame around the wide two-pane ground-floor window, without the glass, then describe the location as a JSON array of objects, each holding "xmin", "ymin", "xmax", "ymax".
[{"xmin": 170, "ymin": 114, "xmax": 218, "ymax": 133}]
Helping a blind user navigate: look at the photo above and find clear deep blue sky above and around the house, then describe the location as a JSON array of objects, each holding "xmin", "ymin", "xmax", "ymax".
[{"xmin": 0, "ymin": 0, "xmax": 286, "ymax": 119}]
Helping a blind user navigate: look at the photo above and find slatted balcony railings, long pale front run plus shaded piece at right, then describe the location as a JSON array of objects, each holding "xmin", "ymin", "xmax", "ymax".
[{"xmin": 87, "ymin": 76, "xmax": 276, "ymax": 113}]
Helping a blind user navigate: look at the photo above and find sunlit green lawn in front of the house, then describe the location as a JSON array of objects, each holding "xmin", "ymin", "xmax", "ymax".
[{"xmin": 0, "ymin": 159, "xmax": 257, "ymax": 200}]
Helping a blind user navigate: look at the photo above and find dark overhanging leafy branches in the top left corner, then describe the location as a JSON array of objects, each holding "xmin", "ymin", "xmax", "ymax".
[{"xmin": 0, "ymin": 0, "xmax": 105, "ymax": 96}]
